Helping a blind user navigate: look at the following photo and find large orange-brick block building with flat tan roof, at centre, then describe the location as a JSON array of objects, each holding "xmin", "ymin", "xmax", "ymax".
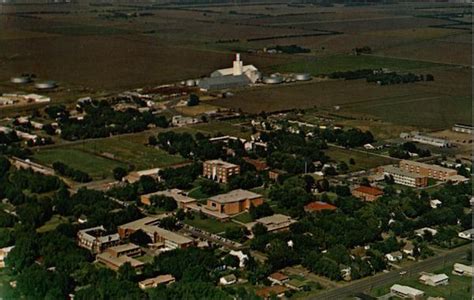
[{"xmin": 206, "ymin": 189, "xmax": 263, "ymax": 215}]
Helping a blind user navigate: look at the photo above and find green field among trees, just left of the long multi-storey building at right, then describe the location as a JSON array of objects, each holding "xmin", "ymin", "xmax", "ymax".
[{"xmin": 324, "ymin": 147, "xmax": 396, "ymax": 172}]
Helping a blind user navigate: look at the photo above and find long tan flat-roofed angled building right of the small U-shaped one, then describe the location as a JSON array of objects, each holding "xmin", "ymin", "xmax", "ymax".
[{"xmin": 118, "ymin": 214, "xmax": 194, "ymax": 250}]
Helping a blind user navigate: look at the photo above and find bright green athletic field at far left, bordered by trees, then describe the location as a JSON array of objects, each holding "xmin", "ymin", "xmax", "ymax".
[{"xmin": 33, "ymin": 147, "xmax": 126, "ymax": 179}]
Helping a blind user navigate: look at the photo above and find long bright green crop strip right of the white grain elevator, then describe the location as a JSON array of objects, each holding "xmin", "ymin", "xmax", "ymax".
[{"xmin": 275, "ymin": 54, "xmax": 441, "ymax": 75}]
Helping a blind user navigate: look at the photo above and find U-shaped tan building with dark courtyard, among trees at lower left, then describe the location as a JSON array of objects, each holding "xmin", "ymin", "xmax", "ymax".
[{"xmin": 77, "ymin": 226, "xmax": 120, "ymax": 253}]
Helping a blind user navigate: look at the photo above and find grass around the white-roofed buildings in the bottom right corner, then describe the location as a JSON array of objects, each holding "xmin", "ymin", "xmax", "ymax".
[{"xmin": 372, "ymin": 262, "xmax": 472, "ymax": 300}]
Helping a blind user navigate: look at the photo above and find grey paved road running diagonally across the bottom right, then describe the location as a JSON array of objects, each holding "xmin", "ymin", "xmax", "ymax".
[{"xmin": 310, "ymin": 244, "xmax": 471, "ymax": 300}]
